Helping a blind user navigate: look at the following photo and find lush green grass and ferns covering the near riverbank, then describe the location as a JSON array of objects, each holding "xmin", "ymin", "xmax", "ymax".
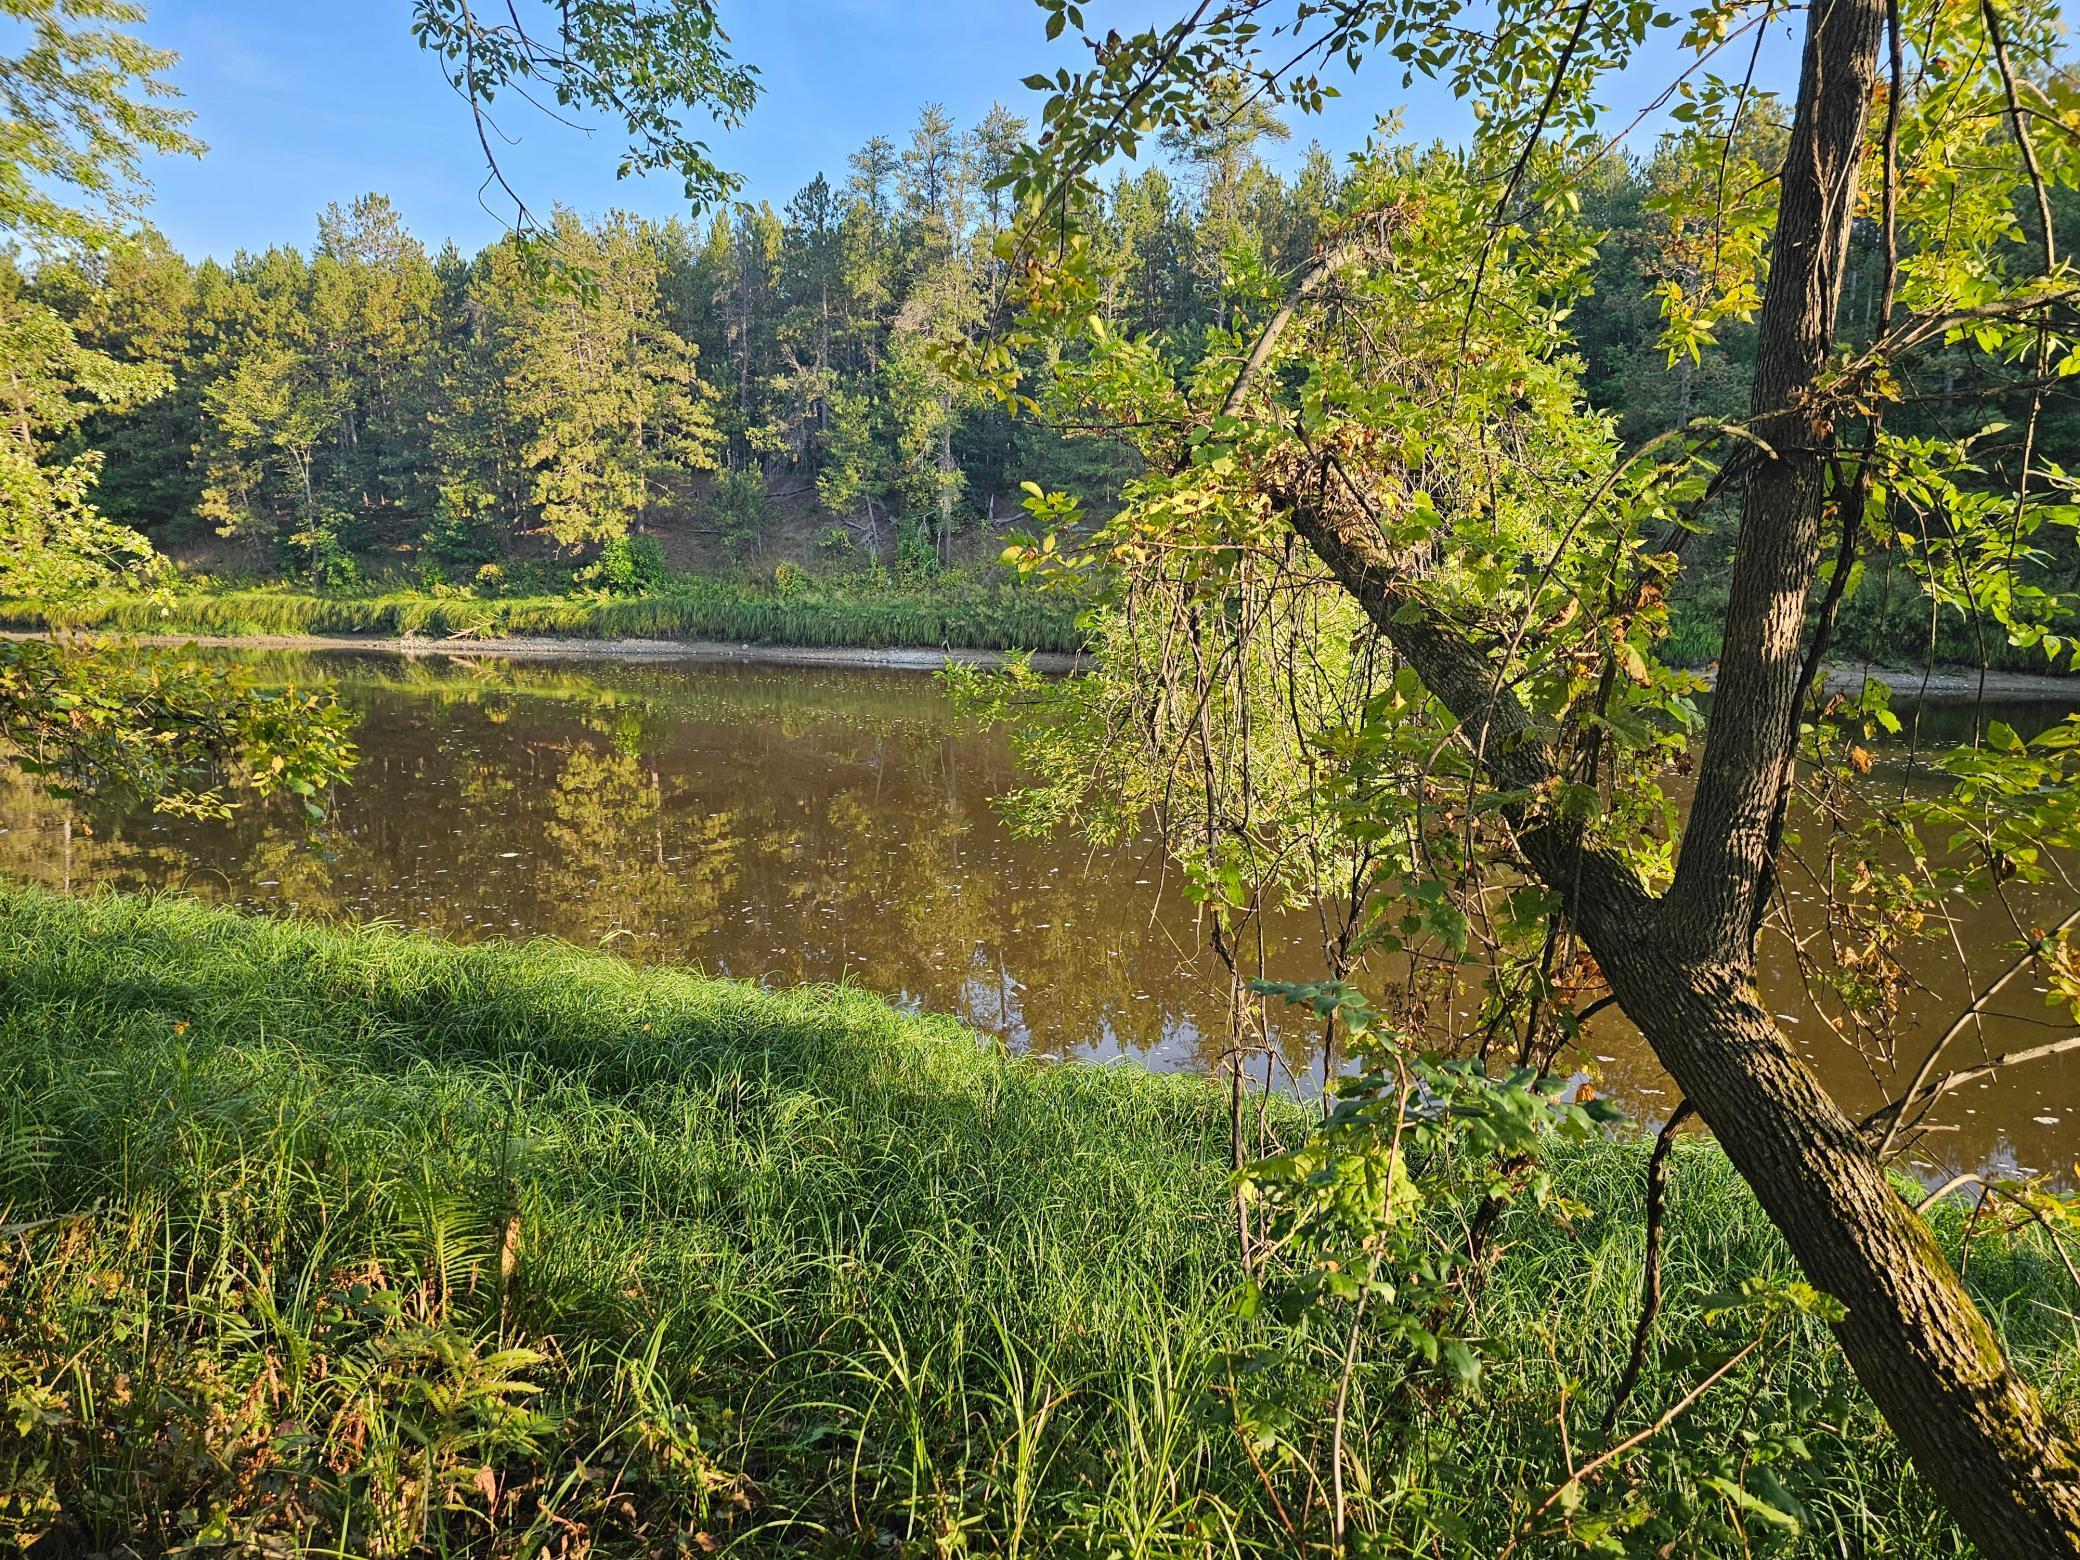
[{"xmin": 0, "ymin": 890, "xmax": 2074, "ymax": 1556}]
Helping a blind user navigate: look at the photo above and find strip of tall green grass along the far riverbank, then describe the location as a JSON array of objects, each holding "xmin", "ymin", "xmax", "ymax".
[{"xmin": 0, "ymin": 576, "xmax": 1082, "ymax": 651}]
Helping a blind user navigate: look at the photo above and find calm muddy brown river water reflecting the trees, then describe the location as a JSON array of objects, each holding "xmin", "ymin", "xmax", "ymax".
[{"xmin": 0, "ymin": 655, "xmax": 2080, "ymax": 1175}]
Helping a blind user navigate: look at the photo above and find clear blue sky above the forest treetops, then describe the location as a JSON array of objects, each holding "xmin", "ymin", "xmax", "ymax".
[{"xmin": 121, "ymin": 0, "xmax": 1797, "ymax": 258}]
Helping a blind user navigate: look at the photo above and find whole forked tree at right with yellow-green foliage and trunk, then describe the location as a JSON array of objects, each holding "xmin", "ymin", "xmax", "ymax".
[{"xmin": 965, "ymin": 0, "xmax": 2080, "ymax": 1556}]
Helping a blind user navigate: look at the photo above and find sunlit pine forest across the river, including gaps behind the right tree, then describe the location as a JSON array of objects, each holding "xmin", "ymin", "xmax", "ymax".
[{"xmin": 16, "ymin": 98, "xmax": 2080, "ymax": 653}]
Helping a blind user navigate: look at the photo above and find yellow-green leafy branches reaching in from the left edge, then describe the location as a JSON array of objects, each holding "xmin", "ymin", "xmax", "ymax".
[{"xmin": 0, "ymin": 0, "xmax": 352, "ymax": 817}]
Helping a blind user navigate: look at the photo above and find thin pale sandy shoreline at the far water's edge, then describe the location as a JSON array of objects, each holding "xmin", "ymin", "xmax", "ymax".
[{"xmin": 16, "ymin": 630, "xmax": 2080, "ymax": 709}]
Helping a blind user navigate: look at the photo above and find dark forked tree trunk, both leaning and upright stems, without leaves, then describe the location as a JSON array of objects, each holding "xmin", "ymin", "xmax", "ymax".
[{"xmin": 1272, "ymin": 0, "xmax": 2080, "ymax": 1560}]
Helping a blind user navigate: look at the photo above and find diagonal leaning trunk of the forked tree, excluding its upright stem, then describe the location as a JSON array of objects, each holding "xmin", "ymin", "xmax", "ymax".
[{"xmin": 1294, "ymin": 503, "xmax": 2080, "ymax": 1560}]
